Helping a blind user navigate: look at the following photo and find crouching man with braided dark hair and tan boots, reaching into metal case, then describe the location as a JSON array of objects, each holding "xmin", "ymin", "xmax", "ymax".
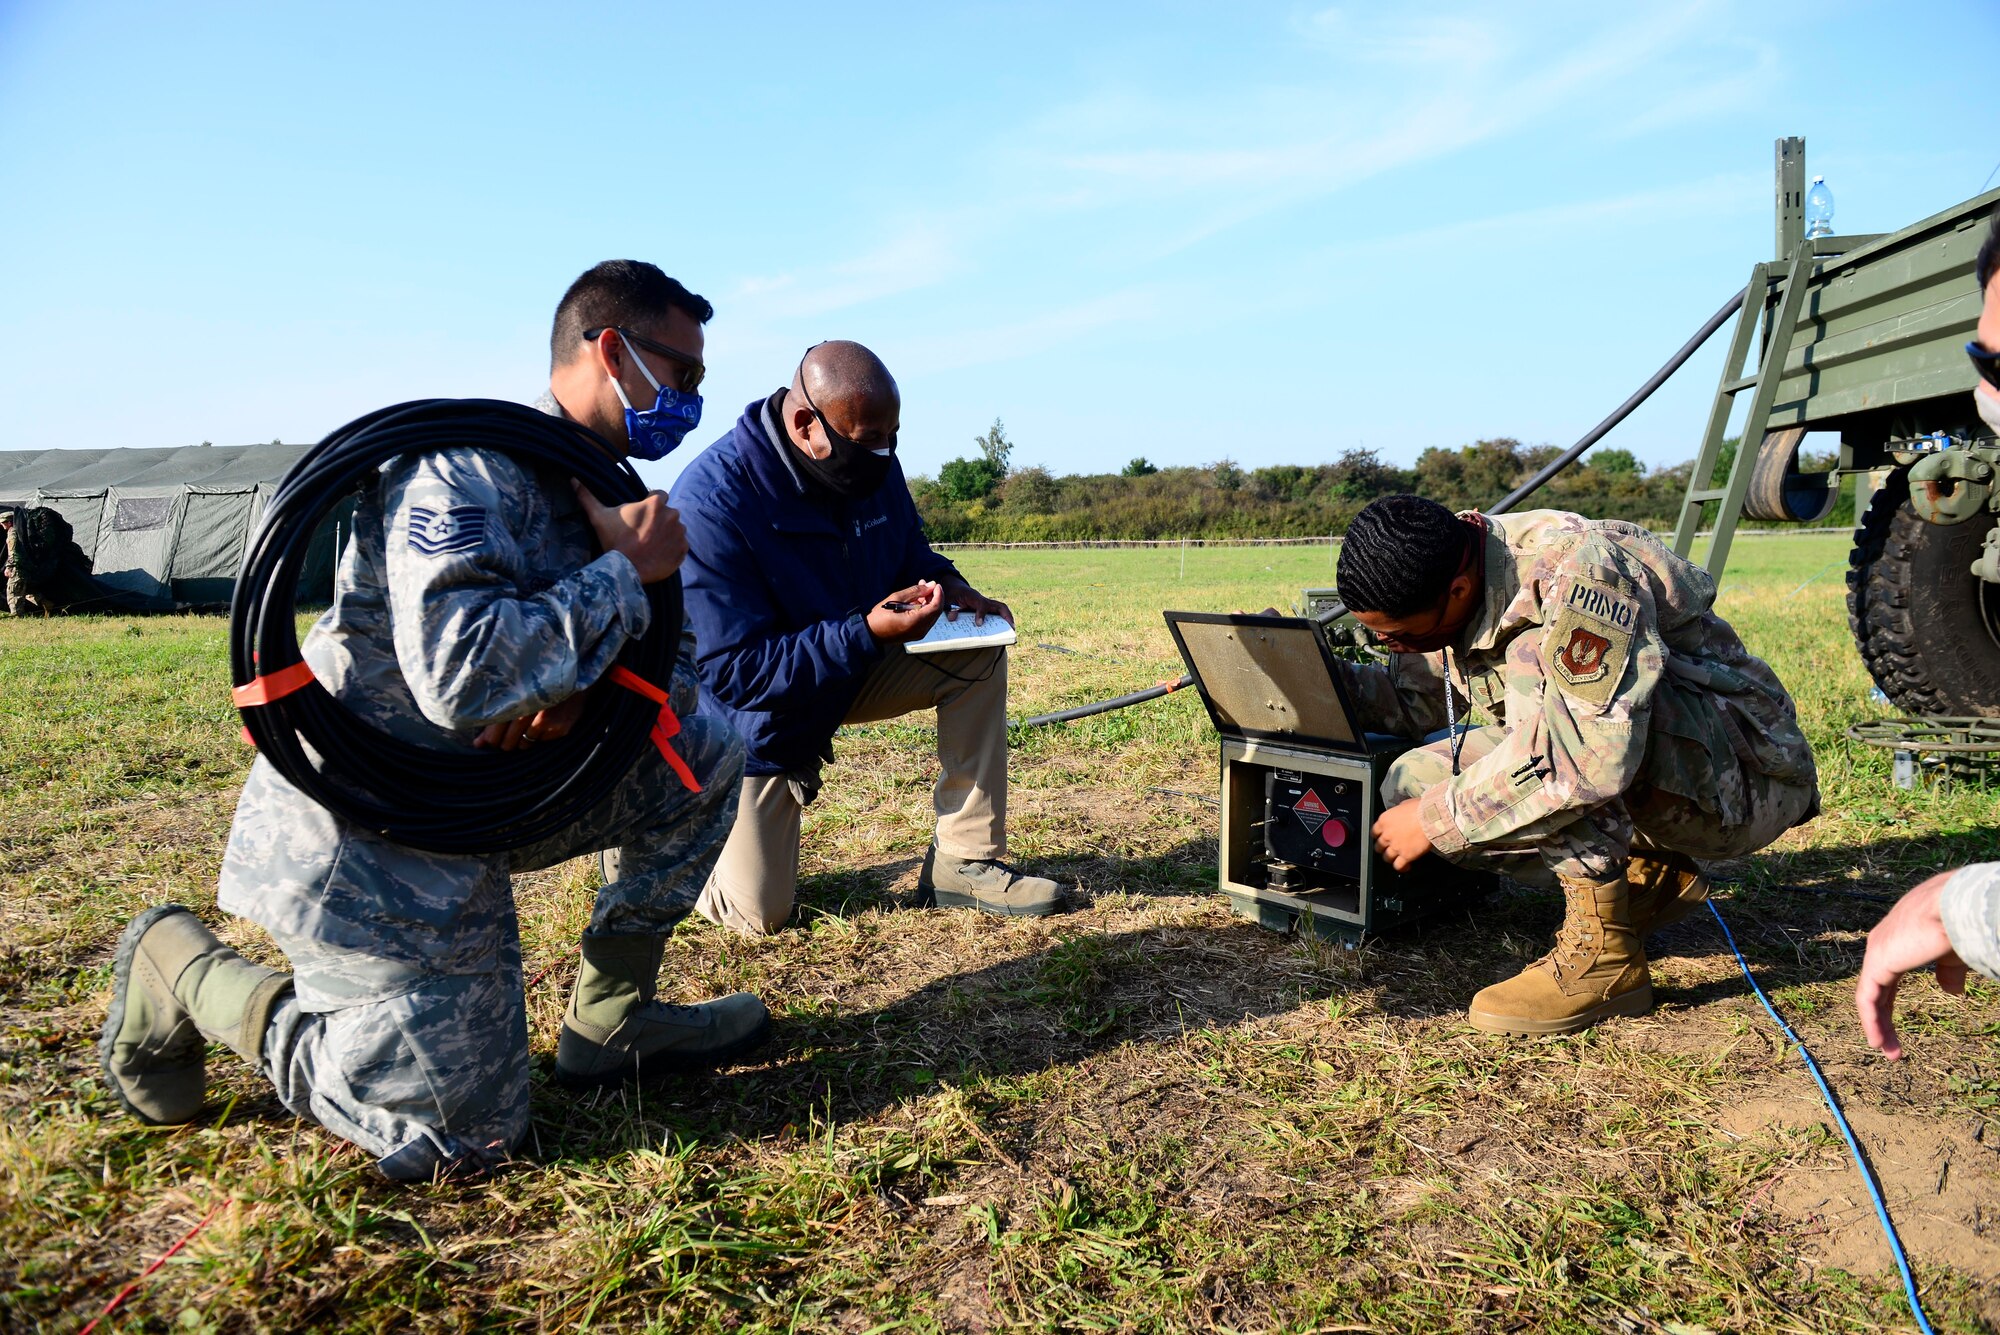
[{"xmin": 1338, "ymin": 496, "xmax": 1820, "ymax": 1033}]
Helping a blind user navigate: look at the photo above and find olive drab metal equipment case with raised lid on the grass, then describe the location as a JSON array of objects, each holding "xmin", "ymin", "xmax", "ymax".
[{"xmin": 1166, "ymin": 612, "xmax": 1470, "ymax": 937}]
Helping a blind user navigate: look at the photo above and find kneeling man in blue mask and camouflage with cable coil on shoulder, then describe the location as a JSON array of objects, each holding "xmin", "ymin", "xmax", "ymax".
[{"xmin": 102, "ymin": 262, "xmax": 770, "ymax": 1179}]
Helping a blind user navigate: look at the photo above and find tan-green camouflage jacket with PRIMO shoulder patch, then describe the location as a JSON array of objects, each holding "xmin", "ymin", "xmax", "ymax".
[{"xmin": 1344, "ymin": 510, "xmax": 1814, "ymax": 853}]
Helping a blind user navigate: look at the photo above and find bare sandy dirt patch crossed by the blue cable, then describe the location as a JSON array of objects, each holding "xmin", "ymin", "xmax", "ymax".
[{"xmin": 1720, "ymin": 1099, "xmax": 2000, "ymax": 1281}]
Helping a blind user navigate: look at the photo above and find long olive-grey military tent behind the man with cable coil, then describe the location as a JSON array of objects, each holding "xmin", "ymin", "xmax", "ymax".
[{"xmin": 0, "ymin": 444, "xmax": 352, "ymax": 610}]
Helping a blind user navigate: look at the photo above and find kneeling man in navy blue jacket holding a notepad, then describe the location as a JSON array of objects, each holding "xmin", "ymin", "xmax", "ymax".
[{"xmin": 674, "ymin": 342, "xmax": 1060, "ymax": 933}]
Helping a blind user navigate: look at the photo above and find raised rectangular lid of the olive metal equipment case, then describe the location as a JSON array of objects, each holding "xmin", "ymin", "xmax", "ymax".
[{"xmin": 1164, "ymin": 612, "xmax": 1368, "ymax": 751}]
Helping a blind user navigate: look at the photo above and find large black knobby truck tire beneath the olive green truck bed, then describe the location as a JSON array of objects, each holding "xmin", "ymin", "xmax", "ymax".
[{"xmin": 1848, "ymin": 468, "xmax": 2000, "ymax": 717}]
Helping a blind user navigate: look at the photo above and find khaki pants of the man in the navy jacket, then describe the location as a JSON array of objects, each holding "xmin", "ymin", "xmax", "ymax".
[{"xmin": 694, "ymin": 648, "xmax": 1006, "ymax": 935}]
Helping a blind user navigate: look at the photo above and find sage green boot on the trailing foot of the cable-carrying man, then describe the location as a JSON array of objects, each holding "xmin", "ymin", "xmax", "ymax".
[{"xmin": 98, "ymin": 903, "xmax": 292, "ymax": 1125}]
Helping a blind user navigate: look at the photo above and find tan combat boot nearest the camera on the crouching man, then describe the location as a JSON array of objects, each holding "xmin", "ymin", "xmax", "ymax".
[{"xmin": 1466, "ymin": 875, "xmax": 1652, "ymax": 1033}]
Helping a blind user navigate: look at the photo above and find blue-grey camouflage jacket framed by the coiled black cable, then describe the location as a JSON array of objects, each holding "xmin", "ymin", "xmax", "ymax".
[{"xmin": 302, "ymin": 396, "xmax": 698, "ymax": 747}]
